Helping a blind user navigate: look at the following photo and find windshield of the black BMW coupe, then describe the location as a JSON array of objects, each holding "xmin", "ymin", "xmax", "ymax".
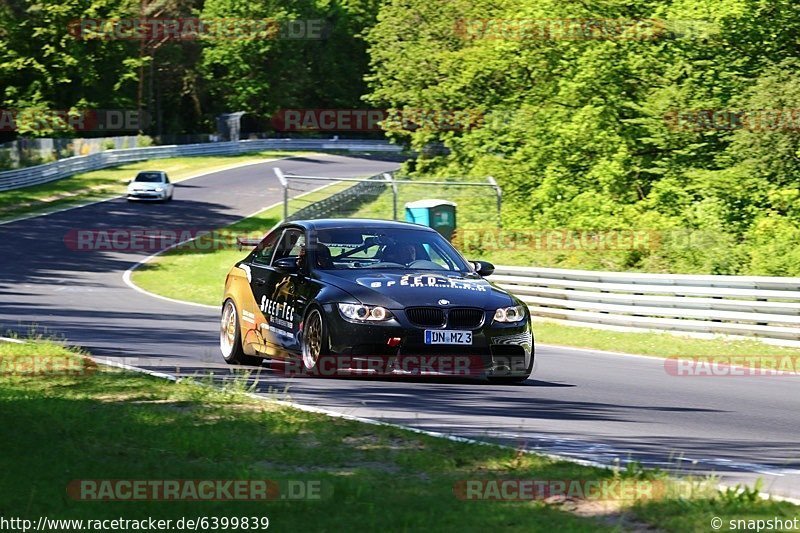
[{"xmin": 311, "ymin": 227, "xmax": 471, "ymax": 273}]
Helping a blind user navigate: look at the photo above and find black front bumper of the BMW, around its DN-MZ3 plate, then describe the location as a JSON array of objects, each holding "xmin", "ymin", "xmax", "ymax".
[{"xmin": 318, "ymin": 306, "xmax": 534, "ymax": 377}]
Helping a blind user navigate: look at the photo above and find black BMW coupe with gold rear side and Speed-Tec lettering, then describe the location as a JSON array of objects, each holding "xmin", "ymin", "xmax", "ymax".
[{"xmin": 220, "ymin": 219, "xmax": 534, "ymax": 383}]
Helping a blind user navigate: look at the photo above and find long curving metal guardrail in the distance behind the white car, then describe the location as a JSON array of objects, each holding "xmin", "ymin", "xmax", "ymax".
[{"xmin": 0, "ymin": 139, "xmax": 402, "ymax": 191}]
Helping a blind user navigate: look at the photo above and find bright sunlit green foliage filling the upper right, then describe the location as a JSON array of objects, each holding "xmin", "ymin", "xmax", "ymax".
[{"xmin": 369, "ymin": 0, "xmax": 800, "ymax": 275}]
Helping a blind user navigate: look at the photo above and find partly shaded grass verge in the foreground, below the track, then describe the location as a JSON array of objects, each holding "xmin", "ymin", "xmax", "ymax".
[{"xmin": 0, "ymin": 341, "xmax": 798, "ymax": 531}]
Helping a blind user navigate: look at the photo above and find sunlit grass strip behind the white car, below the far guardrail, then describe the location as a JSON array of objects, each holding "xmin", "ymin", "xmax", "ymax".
[{"xmin": 0, "ymin": 151, "xmax": 306, "ymax": 221}]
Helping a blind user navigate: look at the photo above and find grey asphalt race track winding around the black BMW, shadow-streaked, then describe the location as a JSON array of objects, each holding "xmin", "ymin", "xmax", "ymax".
[{"xmin": 0, "ymin": 155, "xmax": 800, "ymax": 498}]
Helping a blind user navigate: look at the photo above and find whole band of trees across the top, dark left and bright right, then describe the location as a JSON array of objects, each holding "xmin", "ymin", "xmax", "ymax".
[{"xmin": 0, "ymin": 0, "xmax": 800, "ymax": 275}]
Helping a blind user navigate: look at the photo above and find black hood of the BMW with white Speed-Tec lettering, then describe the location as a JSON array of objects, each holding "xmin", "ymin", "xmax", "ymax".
[{"xmin": 318, "ymin": 270, "xmax": 517, "ymax": 309}]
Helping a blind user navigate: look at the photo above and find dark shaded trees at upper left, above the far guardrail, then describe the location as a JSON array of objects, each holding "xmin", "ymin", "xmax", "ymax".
[{"xmin": 0, "ymin": 0, "xmax": 380, "ymax": 137}]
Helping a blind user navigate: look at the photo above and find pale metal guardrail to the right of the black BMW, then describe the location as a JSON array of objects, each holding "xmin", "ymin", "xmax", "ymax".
[{"xmin": 491, "ymin": 266, "xmax": 800, "ymax": 341}]
